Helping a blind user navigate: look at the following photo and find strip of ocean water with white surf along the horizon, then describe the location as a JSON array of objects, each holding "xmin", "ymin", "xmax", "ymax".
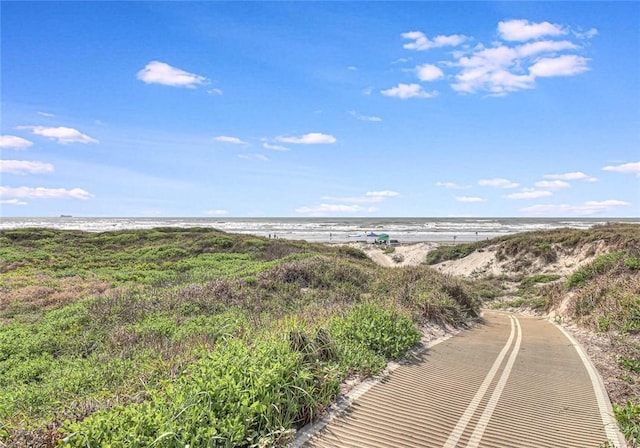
[{"xmin": 0, "ymin": 217, "xmax": 640, "ymax": 243}]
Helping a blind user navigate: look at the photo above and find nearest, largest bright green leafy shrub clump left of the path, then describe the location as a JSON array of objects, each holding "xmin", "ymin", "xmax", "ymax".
[{"xmin": 63, "ymin": 339, "xmax": 339, "ymax": 447}]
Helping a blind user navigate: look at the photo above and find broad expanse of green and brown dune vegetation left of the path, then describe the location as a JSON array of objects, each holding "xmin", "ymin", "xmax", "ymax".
[{"xmin": 0, "ymin": 228, "xmax": 479, "ymax": 447}]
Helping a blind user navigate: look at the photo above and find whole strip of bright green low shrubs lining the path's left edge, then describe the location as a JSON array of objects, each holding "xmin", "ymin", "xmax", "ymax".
[{"xmin": 63, "ymin": 303, "xmax": 420, "ymax": 448}]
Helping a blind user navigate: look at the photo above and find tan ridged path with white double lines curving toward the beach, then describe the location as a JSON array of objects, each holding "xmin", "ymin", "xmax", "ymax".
[{"xmin": 304, "ymin": 312, "xmax": 624, "ymax": 448}]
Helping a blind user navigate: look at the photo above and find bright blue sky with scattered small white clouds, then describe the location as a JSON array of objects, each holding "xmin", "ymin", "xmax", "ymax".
[{"xmin": 0, "ymin": 1, "xmax": 640, "ymax": 217}]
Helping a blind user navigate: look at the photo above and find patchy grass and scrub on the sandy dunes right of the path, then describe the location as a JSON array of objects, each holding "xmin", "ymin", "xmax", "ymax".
[{"xmin": 427, "ymin": 224, "xmax": 640, "ymax": 447}]
